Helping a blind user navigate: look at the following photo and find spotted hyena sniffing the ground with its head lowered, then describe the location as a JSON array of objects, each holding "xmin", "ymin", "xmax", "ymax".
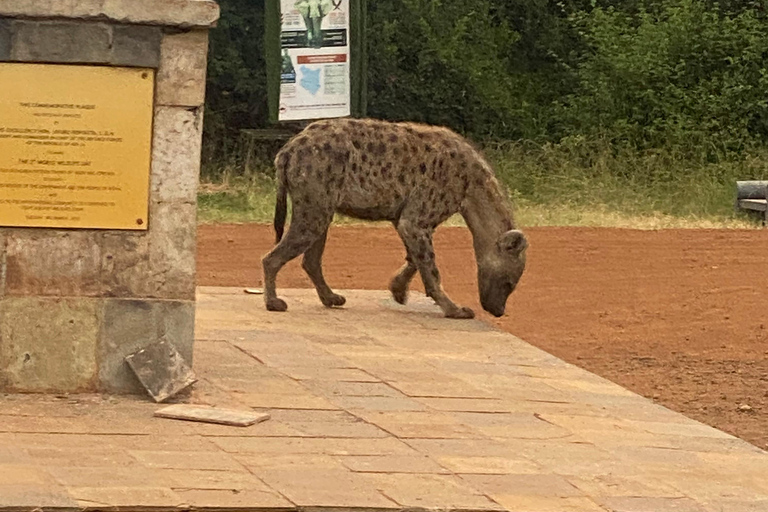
[{"xmin": 262, "ymin": 119, "xmax": 528, "ymax": 318}]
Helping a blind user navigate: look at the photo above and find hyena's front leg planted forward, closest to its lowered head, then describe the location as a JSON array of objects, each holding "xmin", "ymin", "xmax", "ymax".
[{"xmin": 397, "ymin": 217, "xmax": 475, "ymax": 318}]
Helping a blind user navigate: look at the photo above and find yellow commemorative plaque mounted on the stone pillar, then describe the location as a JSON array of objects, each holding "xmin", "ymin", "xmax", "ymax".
[{"xmin": 0, "ymin": 63, "xmax": 155, "ymax": 230}]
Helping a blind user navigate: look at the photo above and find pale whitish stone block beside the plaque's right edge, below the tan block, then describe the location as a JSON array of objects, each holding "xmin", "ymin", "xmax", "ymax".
[{"xmin": 151, "ymin": 107, "xmax": 203, "ymax": 203}]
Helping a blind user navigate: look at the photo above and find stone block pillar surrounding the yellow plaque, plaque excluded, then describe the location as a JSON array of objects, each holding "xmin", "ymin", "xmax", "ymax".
[{"xmin": 0, "ymin": 0, "xmax": 219, "ymax": 393}]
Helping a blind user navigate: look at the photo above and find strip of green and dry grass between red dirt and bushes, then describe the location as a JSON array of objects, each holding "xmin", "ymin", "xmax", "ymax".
[{"xmin": 199, "ymin": 142, "xmax": 768, "ymax": 229}]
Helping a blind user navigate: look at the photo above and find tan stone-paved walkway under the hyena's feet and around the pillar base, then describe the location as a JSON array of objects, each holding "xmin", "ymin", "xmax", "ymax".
[{"xmin": 0, "ymin": 288, "xmax": 768, "ymax": 512}]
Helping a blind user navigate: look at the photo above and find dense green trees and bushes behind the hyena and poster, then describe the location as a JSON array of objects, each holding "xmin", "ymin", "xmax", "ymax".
[{"xmin": 204, "ymin": 0, "xmax": 768, "ymax": 224}]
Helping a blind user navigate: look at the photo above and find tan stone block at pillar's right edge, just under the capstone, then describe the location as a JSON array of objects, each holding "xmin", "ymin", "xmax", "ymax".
[{"xmin": 156, "ymin": 30, "xmax": 208, "ymax": 107}]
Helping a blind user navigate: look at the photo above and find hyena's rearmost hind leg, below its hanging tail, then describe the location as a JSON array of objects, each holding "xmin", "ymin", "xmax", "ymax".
[{"xmin": 261, "ymin": 201, "xmax": 333, "ymax": 311}]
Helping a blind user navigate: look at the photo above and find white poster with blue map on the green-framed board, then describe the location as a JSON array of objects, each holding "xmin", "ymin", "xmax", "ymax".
[{"xmin": 279, "ymin": 0, "xmax": 351, "ymax": 121}]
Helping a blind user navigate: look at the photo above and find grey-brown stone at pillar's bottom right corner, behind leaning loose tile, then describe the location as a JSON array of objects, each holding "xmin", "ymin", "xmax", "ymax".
[{"xmin": 98, "ymin": 299, "xmax": 194, "ymax": 394}]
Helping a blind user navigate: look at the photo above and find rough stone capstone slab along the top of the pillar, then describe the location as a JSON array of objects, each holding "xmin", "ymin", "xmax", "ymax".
[{"xmin": 0, "ymin": 0, "xmax": 219, "ymax": 27}]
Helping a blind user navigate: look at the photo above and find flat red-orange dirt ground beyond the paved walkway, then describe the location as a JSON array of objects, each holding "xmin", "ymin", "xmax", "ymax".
[{"xmin": 198, "ymin": 225, "xmax": 768, "ymax": 448}]
